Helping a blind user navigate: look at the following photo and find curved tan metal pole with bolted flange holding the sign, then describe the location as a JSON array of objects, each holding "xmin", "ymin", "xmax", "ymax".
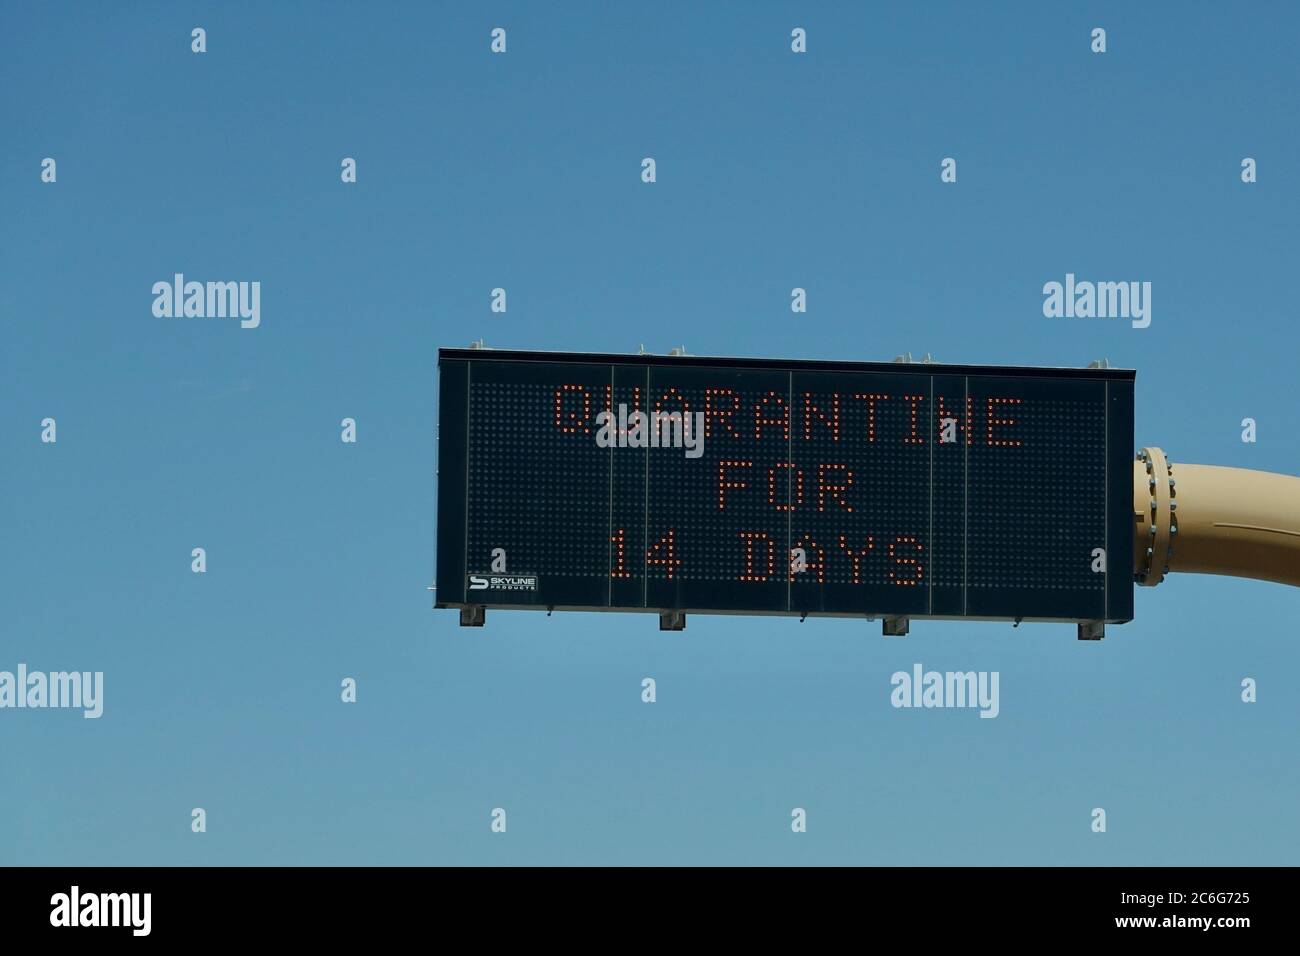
[{"xmin": 1134, "ymin": 447, "xmax": 1300, "ymax": 587}]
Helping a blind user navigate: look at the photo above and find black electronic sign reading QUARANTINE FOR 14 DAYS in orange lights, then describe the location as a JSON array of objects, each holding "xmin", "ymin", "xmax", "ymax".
[{"xmin": 436, "ymin": 349, "xmax": 1134, "ymax": 623}]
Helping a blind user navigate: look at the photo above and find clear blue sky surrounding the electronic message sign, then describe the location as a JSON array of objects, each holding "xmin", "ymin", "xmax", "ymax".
[{"xmin": 0, "ymin": 3, "xmax": 1300, "ymax": 864}]
